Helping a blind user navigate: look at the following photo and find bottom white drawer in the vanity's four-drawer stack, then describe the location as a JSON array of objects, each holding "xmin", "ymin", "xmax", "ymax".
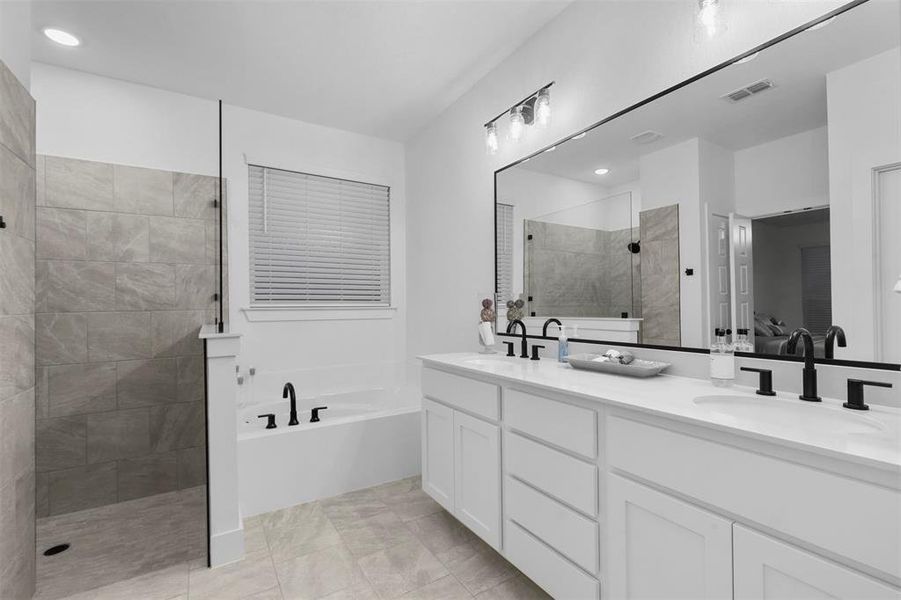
[{"xmin": 504, "ymin": 521, "xmax": 600, "ymax": 600}]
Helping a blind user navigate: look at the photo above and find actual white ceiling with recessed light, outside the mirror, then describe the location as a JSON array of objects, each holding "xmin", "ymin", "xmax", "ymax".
[{"xmin": 32, "ymin": 0, "xmax": 569, "ymax": 140}]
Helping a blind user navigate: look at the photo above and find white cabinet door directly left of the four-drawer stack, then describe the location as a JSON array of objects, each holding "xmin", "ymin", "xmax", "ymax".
[{"xmin": 454, "ymin": 412, "xmax": 501, "ymax": 549}]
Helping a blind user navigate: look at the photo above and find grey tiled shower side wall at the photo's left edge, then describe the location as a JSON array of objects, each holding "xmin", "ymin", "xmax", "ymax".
[{"xmin": 0, "ymin": 57, "xmax": 35, "ymax": 598}]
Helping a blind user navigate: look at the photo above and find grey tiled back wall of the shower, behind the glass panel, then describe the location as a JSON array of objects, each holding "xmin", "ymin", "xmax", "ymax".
[{"xmin": 35, "ymin": 156, "xmax": 218, "ymax": 516}]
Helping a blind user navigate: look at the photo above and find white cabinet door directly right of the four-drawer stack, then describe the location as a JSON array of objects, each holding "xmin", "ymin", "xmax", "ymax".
[{"xmin": 607, "ymin": 474, "xmax": 732, "ymax": 600}]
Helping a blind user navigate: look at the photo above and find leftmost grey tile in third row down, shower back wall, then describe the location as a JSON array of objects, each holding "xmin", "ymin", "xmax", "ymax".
[{"xmin": 35, "ymin": 260, "xmax": 116, "ymax": 312}]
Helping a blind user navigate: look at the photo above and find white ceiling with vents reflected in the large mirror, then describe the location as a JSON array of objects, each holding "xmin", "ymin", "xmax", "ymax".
[{"xmin": 517, "ymin": 2, "xmax": 901, "ymax": 188}]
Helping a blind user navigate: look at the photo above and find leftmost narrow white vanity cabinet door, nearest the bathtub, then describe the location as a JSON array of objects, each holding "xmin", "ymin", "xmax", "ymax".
[{"xmin": 422, "ymin": 398, "xmax": 454, "ymax": 513}]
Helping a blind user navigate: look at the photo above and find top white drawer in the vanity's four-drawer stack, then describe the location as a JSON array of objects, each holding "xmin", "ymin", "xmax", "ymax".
[{"xmin": 504, "ymin": 389, "xmax": 598, "ymax": 458}]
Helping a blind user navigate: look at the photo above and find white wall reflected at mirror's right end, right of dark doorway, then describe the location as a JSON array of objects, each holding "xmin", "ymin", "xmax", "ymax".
[{"xmin": 826, "ymin": 48, "xmax": 901, "ymax": 360}]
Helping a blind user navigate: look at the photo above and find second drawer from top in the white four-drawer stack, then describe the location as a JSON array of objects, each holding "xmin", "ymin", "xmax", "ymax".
[{"xmin": 505, "ymin": 433, "xmax": 598, "ymax": 516}]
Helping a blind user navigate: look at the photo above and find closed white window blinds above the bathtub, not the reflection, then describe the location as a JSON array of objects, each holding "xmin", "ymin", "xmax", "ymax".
[{"xmin": 248, "ymin": 165, "xmax": 391, "ymax": 306}]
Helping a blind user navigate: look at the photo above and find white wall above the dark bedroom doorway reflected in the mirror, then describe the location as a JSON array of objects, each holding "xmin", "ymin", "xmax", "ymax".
[{"xmin": 735, "ymin": 126, "xmax": 829, "ymax": 217}]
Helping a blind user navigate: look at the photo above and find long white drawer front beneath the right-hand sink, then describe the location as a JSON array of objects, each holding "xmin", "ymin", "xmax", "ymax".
[{"xmin": 605, "ymin": 417, "xmax": 901, "ymax": 578}]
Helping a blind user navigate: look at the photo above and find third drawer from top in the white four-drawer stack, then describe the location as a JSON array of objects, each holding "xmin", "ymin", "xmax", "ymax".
[{"xmin": 505, "ymin": 477, "xmax": 598, "ymax": 573}]
